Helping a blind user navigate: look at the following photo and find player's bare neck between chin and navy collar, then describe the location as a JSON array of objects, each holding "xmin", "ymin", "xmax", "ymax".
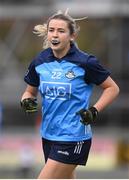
[{"xmin": 53, "ymin": 45, "xmax": 70, "ymax": 59}]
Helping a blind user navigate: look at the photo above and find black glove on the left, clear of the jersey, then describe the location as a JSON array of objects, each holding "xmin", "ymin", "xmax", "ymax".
[{"xmin": 20, "ymin": 98, "xmax": 38, "ymax": 113}]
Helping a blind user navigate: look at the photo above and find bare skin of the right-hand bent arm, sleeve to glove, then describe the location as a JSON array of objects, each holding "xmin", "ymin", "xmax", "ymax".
[{"xmin": 94, "ymin": 77, "xmax": 119, "ymax": 111}]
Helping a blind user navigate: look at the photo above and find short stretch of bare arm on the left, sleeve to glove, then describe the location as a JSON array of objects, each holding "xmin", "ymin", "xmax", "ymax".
[{"xmin": 21, "ymin": 85, "xmax": 38, "ymax": 101}]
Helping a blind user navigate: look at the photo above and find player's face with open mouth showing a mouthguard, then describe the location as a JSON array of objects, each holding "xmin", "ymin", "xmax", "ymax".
[{"xmin": 47, "ymin": 19, "xmax": 74, "ymax": 54}]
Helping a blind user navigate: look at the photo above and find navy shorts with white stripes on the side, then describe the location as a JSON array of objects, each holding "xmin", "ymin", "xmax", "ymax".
[{"xmin": 42, "ymin": 138, "xmax": 91, "ymax": 165}]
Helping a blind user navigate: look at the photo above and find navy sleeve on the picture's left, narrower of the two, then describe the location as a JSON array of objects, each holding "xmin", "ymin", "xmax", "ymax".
[{"xmin": 24, "ymin": 60, "xmax": 39, "ymax": 87}]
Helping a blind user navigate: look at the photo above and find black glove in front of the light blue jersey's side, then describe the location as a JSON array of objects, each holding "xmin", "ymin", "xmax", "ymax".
[{"xmin": 77, "ymin": 107, "xmax": 98, "ymax": 125}]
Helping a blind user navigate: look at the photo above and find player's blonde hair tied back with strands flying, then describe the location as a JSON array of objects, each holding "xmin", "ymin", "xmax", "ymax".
[{"xmin": 33, "ymin": 9, "xmax": 87, "ymax": 49}]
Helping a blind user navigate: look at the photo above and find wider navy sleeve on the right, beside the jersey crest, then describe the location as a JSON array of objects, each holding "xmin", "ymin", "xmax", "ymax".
[{"xmin": 85, "ymin": 55, "xmax": 110, "ymax": 85}]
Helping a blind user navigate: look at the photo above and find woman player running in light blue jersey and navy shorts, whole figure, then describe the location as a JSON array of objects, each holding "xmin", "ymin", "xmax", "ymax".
[{"xmin": 21, "ymin": 9, "xmax": 119, "ymax": 179}]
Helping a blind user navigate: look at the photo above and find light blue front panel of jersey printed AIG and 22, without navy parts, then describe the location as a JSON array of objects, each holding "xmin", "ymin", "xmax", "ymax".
[{"xmin": 36, "ymin": 60, "xmax": 92, "ymax": 141}]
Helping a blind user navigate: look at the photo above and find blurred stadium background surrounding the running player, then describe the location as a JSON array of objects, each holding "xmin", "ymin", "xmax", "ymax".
[{"xmin": 0, "ymin": 0, "xmax": 129, "ymax": 179}]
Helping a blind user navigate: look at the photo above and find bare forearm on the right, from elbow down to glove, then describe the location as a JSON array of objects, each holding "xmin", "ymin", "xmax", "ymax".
[{"xmin": 94, "ymin": 86, "xmax": 119, "ymax": 112}]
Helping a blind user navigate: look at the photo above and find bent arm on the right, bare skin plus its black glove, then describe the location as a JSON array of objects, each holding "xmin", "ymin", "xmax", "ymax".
[{"xmin": 77, "ymin": 76, "xmax": 119, "ymax": 125}]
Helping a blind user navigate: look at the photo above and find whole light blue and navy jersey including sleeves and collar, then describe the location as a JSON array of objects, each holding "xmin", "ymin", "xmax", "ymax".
[{"xmin": 25, "ymin": 45, "xmax": 109, "ymax": 141}]
